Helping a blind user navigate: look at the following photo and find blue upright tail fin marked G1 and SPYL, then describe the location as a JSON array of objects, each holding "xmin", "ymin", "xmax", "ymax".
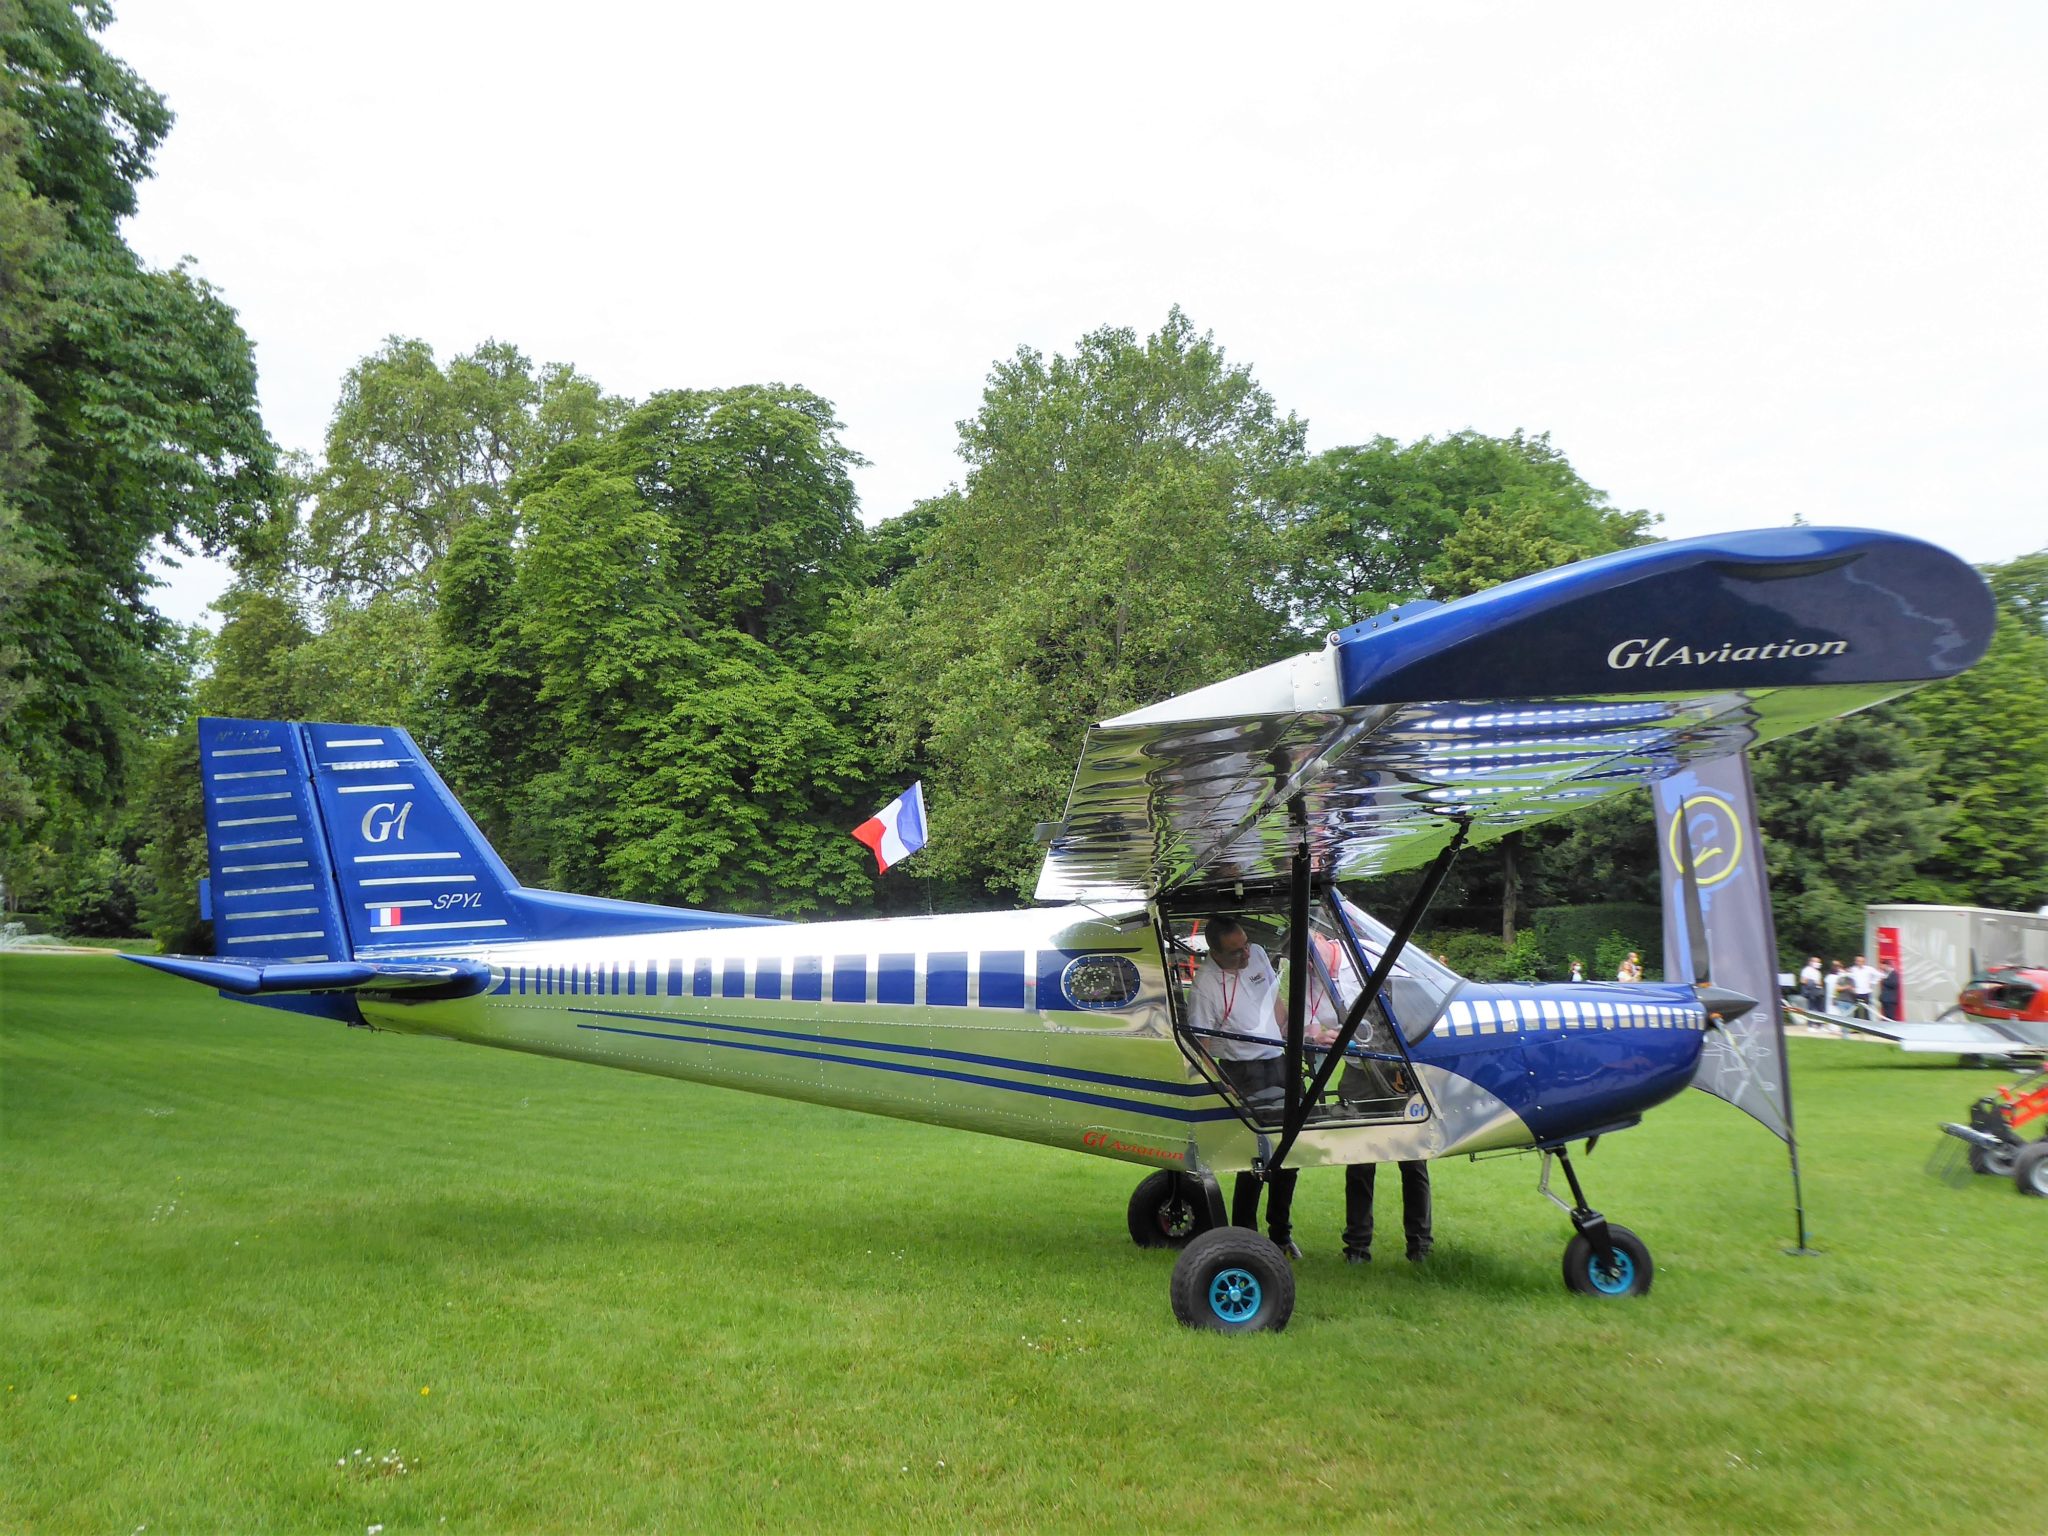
[{"xmin": 199, "ymin": 717, "xmax": 772, "ymax": 965}]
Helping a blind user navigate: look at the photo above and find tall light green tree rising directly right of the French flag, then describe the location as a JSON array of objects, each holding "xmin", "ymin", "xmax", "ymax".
[{"xmin": 862, "ymin": 309, "xmax": 1303, "ymax": 891}]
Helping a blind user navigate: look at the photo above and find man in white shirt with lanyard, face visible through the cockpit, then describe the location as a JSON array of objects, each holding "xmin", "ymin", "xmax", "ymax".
[{"xmin": 1188, "ymin": 918, "xmax": 1300, "ymax": 1260}]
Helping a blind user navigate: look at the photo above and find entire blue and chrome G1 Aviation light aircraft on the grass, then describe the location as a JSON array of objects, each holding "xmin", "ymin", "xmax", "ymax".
[{"xmin": 133, "ymin": 528, "xmax": 1993, "ymax": 1331}]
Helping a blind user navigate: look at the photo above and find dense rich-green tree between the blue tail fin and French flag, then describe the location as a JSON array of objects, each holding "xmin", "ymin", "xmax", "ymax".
[{"xmin": 512, "ymin": 387, "xmax": 872, "ymax": 913}]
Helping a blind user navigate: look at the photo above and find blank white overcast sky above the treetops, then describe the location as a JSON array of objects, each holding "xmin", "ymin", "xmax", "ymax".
[{"xmin": 109, "ymin": 0, "xmax": 2048, "ymax": 621}]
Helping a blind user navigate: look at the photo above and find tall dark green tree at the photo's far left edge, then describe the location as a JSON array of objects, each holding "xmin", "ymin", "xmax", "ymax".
[{"xmin": 0, "ymin": 0, "xmax": 274, "ymax": 835}]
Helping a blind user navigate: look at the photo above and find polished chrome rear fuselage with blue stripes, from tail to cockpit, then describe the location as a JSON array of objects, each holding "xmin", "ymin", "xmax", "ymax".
[{"xmin": 365, "ymin": 907, "xmax": 1249, "ymax": 1167}]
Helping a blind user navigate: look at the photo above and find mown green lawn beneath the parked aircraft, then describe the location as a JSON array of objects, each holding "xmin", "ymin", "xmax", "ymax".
[{"xmin": 0, "ymin": 956, "xmax": 2048, "ymax": 1536}]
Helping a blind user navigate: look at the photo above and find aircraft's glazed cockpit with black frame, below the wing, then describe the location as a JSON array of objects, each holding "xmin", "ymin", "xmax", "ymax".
[{"xmin": 1161, "ymin": 893, "xmax": 1462, "ymax": 1128}]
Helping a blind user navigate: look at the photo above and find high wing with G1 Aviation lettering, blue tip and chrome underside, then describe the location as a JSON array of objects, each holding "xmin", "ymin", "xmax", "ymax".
[{"xmin": 1038, "ymin": 528, "xmax": 1995, "ymax": 901}]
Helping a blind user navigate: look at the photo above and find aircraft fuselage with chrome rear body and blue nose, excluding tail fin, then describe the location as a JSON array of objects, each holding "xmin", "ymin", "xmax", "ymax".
[{"xmin": 339, "ymin": 907, "xmax": 1704, "ymax": 1171}]
